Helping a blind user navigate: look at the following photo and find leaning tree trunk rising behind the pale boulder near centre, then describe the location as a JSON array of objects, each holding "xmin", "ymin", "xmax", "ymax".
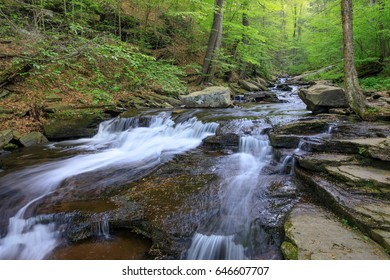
[{"xmin": 199, "ymin": 0, "xmax": 224, "ymax": 84}]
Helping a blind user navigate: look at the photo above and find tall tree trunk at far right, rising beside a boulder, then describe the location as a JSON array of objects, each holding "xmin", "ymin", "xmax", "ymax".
[{"xmin": 341, "ymin": 0, "xmax": 366, "ymax": 117}]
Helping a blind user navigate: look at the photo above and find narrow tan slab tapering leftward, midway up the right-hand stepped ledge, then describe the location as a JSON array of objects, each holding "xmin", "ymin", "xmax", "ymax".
[{"xmin": 325, "ymin": 165, "xmax": 390, "ymax": 189}]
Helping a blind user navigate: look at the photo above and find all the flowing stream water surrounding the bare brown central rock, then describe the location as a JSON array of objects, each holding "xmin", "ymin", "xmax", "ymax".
[{"xmin": 0, "ymin": 80, "xmax": 307, "ymax": 259}]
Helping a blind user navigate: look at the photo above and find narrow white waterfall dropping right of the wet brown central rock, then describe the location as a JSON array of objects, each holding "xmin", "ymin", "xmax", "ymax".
[{"xmin": 186, "ymin": 130, "xmax": 272, "ymax": 260}]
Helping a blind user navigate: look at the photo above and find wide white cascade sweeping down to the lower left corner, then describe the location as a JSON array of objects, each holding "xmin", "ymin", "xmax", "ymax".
[{"xmin": 0, "ymin": 114, "xmax": 218, "ymax": 259}]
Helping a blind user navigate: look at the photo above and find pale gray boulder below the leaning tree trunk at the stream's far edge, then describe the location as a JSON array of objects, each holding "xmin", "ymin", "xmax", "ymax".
[{"xmin": 179, "ymin": 87, "xmax": 232, "ymax": 108}]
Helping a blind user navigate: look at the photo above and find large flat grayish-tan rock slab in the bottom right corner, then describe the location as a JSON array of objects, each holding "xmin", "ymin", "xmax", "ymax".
[{"xmin": 282, "ymin": 203, "xmax": 390, "ymax": 260}]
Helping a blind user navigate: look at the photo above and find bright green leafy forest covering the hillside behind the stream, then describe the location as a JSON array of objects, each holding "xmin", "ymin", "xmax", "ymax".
[{"xmin": 0, "ymin": 0, "xmax": 390, "ymax": 123}]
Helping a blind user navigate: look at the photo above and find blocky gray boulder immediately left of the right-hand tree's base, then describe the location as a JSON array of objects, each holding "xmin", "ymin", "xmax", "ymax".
[{"xmin": 298, "ymin": 82, "xmax": 348, "ymax": 114}]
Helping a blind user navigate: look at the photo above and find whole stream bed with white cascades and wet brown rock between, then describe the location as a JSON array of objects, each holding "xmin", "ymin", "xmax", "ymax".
[{"xmin": 0, "ymin": 82, "xmax": 314, "ymax": 259}]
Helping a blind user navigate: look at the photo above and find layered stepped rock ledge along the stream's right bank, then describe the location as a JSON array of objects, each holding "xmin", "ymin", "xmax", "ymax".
[{"xmin": 270, "ymin": 114, "xmax": 390, "ymax": 259}]
